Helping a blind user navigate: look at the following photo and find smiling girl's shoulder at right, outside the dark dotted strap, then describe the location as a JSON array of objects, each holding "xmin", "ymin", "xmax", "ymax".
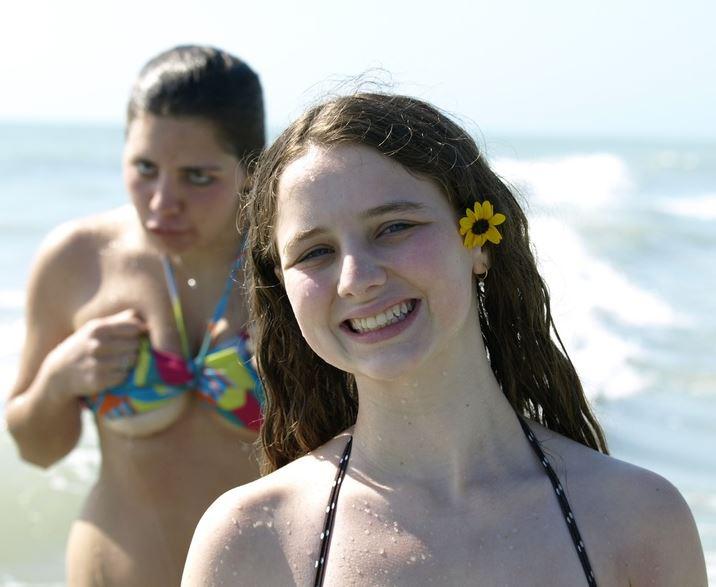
[{"xmin": 531, "ymin": 424, "xmax": 706, "ymax": 585}]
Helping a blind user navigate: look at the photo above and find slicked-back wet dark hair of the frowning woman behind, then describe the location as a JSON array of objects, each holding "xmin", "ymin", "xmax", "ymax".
[{"xmin": 127, "ymin": 45, "xmax": 266, "ymax": 163}]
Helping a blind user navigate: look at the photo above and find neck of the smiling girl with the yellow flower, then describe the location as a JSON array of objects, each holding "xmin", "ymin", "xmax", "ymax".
[{"xmin": 352, "ymin": 341, "xmax": 524, "ymax": 496}]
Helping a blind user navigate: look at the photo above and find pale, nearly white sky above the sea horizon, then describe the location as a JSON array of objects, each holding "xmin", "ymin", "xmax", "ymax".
[{"xmin": 0, "ymin": 0, "xmax": 716, "ymax": 139}]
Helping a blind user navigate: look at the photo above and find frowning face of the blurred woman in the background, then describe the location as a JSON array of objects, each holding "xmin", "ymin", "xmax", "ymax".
[{"xmin": 123, "ymin": 114, "xmax": 244, "ymax": 253}]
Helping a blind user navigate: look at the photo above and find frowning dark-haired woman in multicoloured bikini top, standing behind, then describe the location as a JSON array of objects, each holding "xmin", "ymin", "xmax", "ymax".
[{"xmin": 6, "ymin": 46, "xmax": 264, "ymax": 585}]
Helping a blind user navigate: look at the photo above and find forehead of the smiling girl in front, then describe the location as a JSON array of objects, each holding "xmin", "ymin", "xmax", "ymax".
[{"xmin": 277, "ymin": 145, "xmax": 448, "ymax": 224}]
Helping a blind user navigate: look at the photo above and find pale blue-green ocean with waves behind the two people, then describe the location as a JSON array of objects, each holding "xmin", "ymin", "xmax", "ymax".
[{"xmin": 0, "ymin": 124, "xmax": 716, "ymax": 586}]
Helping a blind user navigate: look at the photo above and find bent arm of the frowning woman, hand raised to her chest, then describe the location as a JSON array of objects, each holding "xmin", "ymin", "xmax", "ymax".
[{"xmin": 5, "ymin": 226, "xmax": 144, "ymax": 467}]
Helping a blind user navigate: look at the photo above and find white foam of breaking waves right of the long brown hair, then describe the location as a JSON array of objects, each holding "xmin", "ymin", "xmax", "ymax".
[{"xmin": 495, "ymin": 154, "xmax": 675, "ymax": 397}]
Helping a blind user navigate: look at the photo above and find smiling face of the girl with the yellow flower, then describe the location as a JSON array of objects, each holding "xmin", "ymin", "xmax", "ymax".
[{"xmin": 275, "ymin": 145, "xmax": 485, "ymax": 379}]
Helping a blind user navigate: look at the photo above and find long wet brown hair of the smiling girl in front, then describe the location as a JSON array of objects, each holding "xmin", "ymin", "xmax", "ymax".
[{"xmin": 247, "ymin": 93, "xmax": 607, "ymax": 473}]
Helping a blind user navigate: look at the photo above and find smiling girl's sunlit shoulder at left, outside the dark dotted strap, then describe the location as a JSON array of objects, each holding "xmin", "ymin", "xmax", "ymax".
[{"xmin": 182, "ymin": 439, "xmax": 352, "ymax": 587}]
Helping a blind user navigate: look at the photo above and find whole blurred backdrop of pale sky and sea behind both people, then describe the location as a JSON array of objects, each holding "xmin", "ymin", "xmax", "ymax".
[{"xmin": 0, "ymin": 0, "xmax": 716, "ymax": 585}]
